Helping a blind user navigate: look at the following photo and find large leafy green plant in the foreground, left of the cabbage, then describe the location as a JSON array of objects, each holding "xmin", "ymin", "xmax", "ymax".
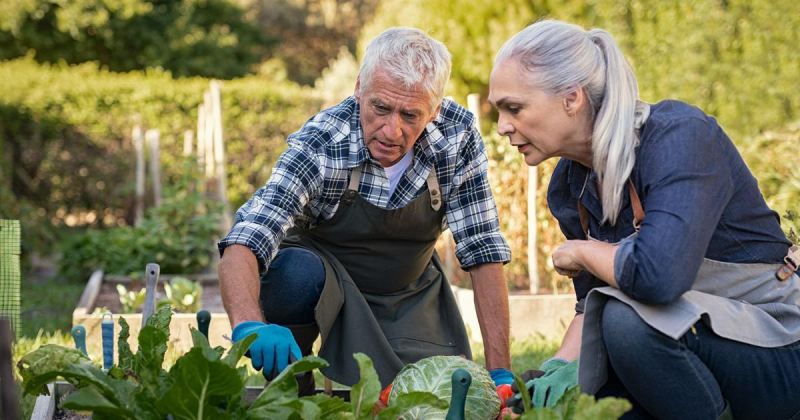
[{"xmin": 17, "ymin": 306, "xmax": 447, "ymax": 420}]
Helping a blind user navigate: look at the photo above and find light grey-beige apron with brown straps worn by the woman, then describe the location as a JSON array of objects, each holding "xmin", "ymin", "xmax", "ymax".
[{"xmin": 578, "ymin": 101, "xmax": 800, "ymax": 395}]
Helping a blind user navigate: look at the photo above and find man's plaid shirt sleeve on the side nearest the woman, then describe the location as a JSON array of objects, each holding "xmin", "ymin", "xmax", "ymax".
[{"xmin": 447, "ymin": 125, "xmax": 511, "ymax": 270}]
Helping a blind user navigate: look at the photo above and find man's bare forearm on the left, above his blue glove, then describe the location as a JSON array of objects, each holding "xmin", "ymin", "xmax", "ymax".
[{"xmin": 217, "ymin": 245, "xmax": 264, "ymax": 327}]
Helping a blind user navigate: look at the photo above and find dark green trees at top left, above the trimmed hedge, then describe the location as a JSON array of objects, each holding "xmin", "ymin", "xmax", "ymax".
[{"xmin": 0, "ymin": 0, "xmax": 276, "ymax": 79}]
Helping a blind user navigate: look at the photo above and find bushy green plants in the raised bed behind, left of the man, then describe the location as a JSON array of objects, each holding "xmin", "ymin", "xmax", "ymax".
[{"xmin": 61, "ymin": 160, "xmax": 222, "ymax": 278}]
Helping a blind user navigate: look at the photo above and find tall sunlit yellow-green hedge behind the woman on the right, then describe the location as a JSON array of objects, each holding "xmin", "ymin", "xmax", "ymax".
[{"xmin": 366, "ymin": 0, "xmax": 800, "ymax": 292}]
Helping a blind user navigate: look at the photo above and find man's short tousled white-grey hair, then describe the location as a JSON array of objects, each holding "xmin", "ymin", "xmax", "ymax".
[{"xmin": 358, "ymin": 27, "xmax": 452, "ymax": 109}]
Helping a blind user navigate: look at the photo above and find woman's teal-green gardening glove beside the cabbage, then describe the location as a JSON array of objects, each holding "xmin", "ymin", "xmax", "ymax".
[{"xmin": 505, "ymin": 358, "xmax": 578, "ymax": 414}]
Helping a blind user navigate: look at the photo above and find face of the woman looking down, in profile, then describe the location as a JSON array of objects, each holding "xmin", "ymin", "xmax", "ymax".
[{"xmin": 489, "ymin": 60, "xmax": 585, "ymax": 166}]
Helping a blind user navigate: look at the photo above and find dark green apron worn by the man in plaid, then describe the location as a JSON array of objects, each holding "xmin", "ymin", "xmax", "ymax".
[{"xmin": 282, "ymin": 162, "xmax": 472, "ymax": 387}]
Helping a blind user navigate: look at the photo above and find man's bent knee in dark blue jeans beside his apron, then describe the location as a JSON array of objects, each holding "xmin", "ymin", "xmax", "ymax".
[{"xmin": 260, "ymin": 248, "xmax": 325, "ymax": 325}]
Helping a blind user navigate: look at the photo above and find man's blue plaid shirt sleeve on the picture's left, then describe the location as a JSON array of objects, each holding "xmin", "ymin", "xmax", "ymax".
[{"xmin": 218, "ymin": 141, "xmax": 322, "ymax": 275}]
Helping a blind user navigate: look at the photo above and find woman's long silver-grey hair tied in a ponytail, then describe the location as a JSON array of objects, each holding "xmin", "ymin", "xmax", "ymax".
[{"xmin": 495, "ymin": 20, "xmax": 639, "ymax": 225}]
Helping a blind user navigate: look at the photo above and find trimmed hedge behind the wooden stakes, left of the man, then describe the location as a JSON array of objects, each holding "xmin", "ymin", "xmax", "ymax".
[{"xmin": 0, "ymin": 58, "xmax": 319, "ymax": 240}]
